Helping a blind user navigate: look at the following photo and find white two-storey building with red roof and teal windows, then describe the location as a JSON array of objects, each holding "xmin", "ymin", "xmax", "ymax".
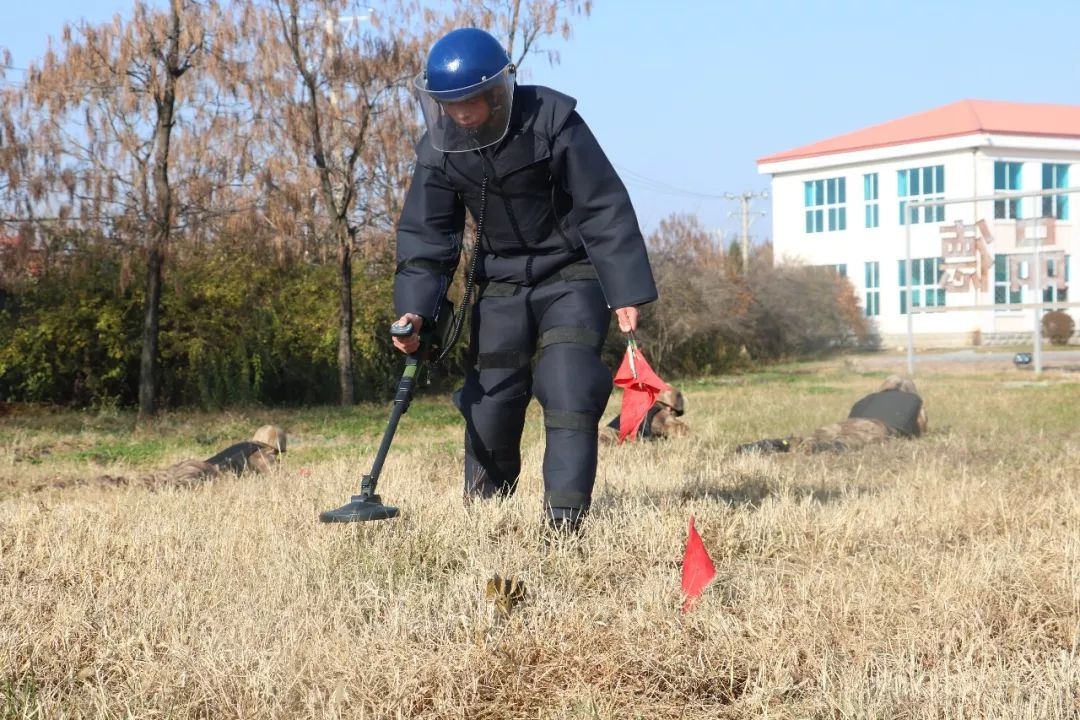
[{"xmin": 758, "ymin": 100, "xmax": 1080, "ymax": 345}]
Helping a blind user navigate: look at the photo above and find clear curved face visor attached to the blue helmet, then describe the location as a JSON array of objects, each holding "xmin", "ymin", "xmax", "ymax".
[{"xmin": 414, "ymin": 65, "xmax": 514, "ymax": 152}]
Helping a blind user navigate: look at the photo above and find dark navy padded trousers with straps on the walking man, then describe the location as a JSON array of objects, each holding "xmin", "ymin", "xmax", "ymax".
[{"xmin": 457, "ymin": 279, "xmax": 612, "ymax": 528}]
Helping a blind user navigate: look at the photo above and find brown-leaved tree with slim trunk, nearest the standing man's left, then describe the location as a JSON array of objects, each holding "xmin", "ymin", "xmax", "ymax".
[{"xmin": 224, "ymin": 0, "xmax": 421, "ymax": 405}]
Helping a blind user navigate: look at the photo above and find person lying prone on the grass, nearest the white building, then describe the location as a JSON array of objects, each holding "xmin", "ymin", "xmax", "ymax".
[{"xmin": 735, "ymin": 375, "xmax": 928, "ymax": 453}]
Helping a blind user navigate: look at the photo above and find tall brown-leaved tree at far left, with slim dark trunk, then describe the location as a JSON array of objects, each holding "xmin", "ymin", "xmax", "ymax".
[{"xmin": 0, "ymin": 0, "xmax": 223, "ymax": 419}]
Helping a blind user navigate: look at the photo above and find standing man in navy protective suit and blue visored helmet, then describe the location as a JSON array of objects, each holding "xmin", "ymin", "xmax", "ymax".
[{"xmin": 394, "ymin": 28, "xmax": 657, "ymax": 531}]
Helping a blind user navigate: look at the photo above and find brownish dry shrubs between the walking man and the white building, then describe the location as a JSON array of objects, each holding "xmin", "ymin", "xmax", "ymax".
[{"xmin": 635, "ymin": 215, "xmax": 877, "ymax": 377}]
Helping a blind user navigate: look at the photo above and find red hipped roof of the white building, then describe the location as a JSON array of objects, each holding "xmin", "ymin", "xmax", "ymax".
[{"xmin": 757, "ymin": 100, "xmax": 1080, "ymax": 163}]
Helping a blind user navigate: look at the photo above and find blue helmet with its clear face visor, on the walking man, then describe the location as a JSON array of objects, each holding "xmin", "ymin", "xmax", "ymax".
[{"xmin": 414, "ymin": 27, "xmax": 516, "ymax": 152}]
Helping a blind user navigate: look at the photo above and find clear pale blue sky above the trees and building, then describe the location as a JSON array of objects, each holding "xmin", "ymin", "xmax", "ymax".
[{"xmin": 6, "ymin": 0, "xmax": 1080, "ymax": 241}]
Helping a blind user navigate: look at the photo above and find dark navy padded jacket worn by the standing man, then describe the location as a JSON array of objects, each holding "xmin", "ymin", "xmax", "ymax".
[{"xmin": 394, "ymin": 85, "xmax": 657, "ymax": 321}]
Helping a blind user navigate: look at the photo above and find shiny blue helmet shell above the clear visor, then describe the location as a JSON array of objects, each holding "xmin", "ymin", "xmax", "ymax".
[{"xmin": 424, "ymin": 27, "xmax": 510, "ymax": 100}]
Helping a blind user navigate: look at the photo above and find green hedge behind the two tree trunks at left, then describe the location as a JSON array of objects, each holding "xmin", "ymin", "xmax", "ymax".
[{"xmin": 0, "ymin": 239, "xmax": 401, "ymax": 409}]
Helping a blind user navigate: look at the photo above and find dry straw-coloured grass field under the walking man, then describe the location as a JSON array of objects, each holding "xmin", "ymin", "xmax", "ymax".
[{"xmin": 0, "ymin": 357, "xmax": 1080, "ymax": 720}]
